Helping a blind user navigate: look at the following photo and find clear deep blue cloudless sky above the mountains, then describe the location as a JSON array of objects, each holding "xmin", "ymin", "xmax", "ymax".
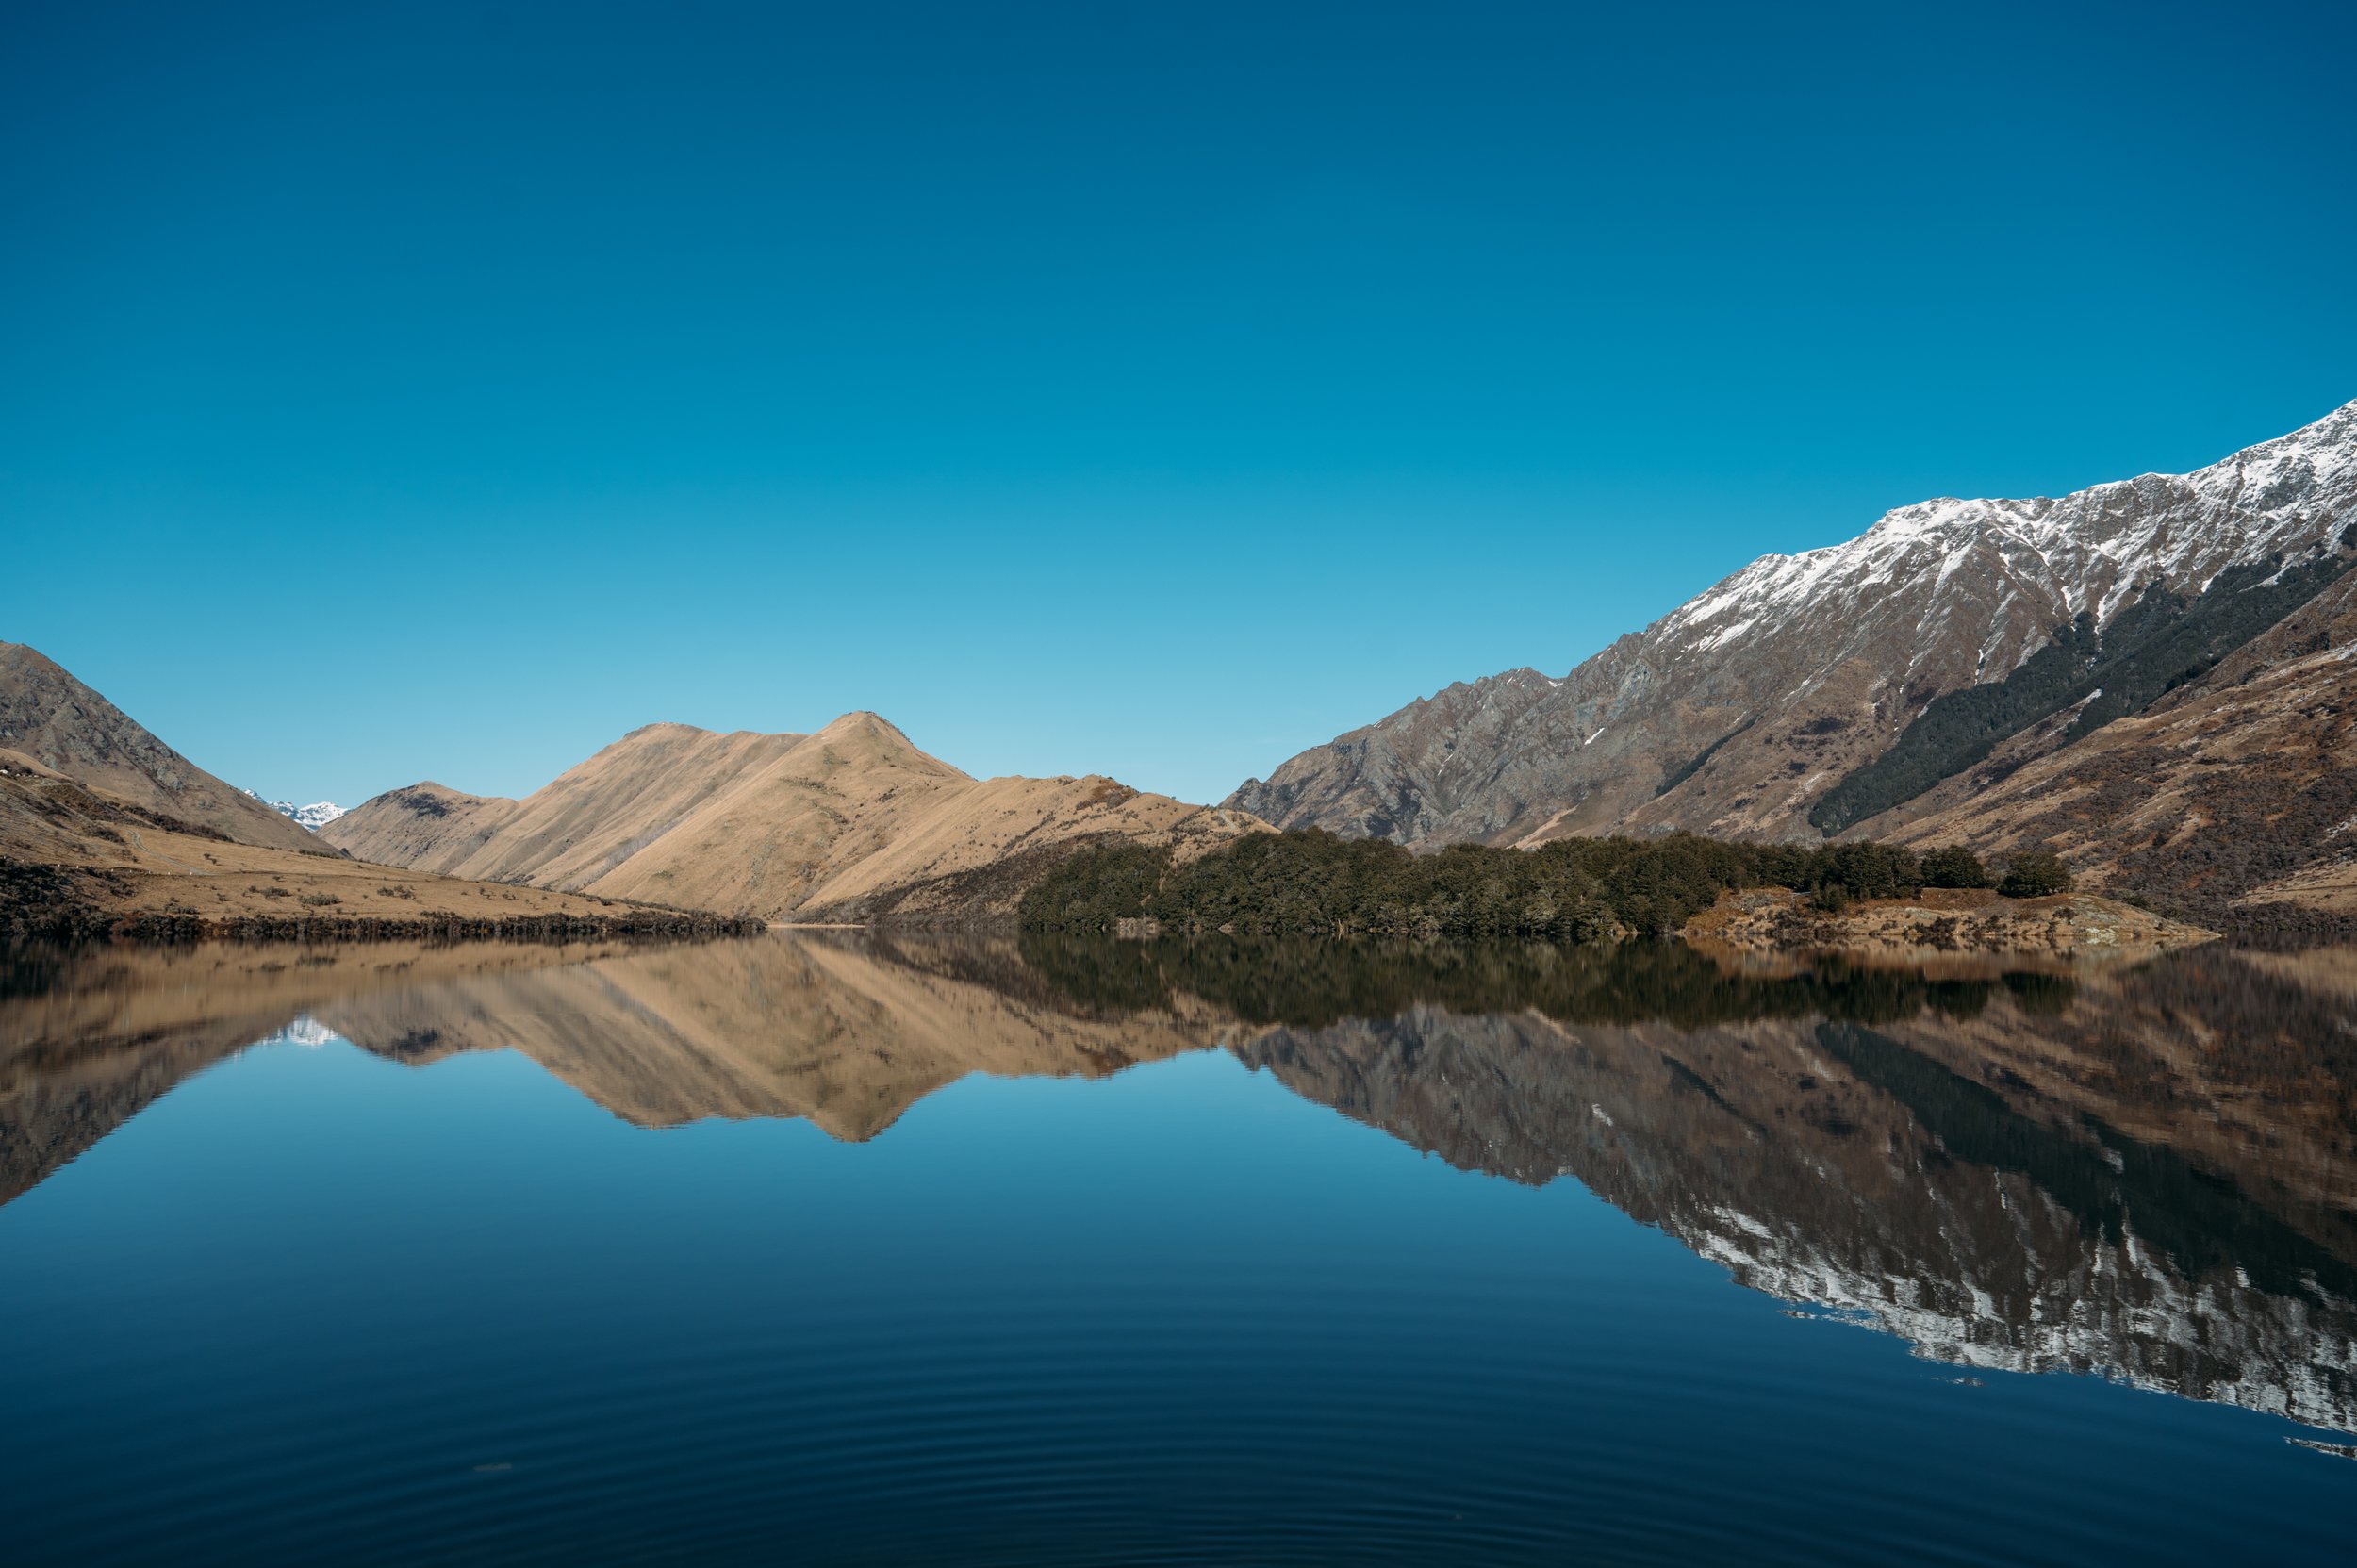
[{"xmin": 0, "ymin": 0, "xmax": 2357, "ymax": 804}]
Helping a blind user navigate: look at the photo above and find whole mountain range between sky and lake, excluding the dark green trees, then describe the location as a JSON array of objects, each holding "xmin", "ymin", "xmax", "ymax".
[{"xmin": 0, "ymin": 404, "xmax": 2357, "ymax": 936}]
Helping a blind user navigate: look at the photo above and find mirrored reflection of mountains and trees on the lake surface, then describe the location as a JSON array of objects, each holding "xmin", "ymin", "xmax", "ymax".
[{"xmin": 0, "ymin": 936, "xmax": 2357, "ymax": 1431}]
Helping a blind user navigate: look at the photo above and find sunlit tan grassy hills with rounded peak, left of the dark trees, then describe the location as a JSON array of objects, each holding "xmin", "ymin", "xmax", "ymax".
[{"xmin": 319, "ymin": 712, "xmax": 1259, "ymax": 919}]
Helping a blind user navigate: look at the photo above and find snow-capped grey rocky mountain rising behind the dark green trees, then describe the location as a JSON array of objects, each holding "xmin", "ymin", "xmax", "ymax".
[{"xmin": 1226, "ymin": 404, "xmax": 2357, "ymax": 919}]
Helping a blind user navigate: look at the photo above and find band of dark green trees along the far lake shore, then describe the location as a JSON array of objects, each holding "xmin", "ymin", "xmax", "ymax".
[{"xmin": 1021, "ymin": 828, "xmax": 2069, "ymax": 941}]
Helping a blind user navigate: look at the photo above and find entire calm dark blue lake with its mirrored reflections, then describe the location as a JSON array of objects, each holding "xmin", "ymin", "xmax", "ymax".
[{"xmin": 0, "ymin": 936, "xmax": 2357, "ymax": 1563}]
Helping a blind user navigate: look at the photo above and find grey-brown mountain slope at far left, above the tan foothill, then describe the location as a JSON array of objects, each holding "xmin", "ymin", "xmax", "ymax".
[{"xmin": 0, "ymin": 641, "xmax": 319, "ymax": 849}]
